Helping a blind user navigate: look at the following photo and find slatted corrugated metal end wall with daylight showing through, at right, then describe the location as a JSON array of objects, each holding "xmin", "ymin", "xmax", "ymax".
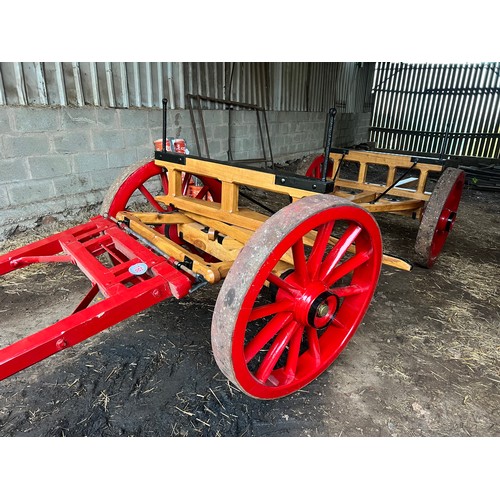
[{"xmin": 370, "ymin": 62, "xmax": 500, "ymax": 158}]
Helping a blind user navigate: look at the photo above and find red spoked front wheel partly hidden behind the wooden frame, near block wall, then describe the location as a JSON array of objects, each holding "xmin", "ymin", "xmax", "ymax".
[{"xmin": 101, "ymin": 159, "xmax": 221, "ymax": 246}]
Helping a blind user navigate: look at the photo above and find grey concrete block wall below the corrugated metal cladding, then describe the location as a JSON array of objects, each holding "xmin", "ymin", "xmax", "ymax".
[{"xmin": 0, "ymin": 106, "xmax": 370, "ymax": 240}]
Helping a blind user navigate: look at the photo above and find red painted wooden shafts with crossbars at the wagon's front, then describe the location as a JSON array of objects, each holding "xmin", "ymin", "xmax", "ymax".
[{"xmin": 0, "ymin": 216, "xmax": 193, "ymax": 380}]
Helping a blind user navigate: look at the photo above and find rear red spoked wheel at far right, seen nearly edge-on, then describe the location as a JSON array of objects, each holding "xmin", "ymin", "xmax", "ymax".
[{"xmin": 415, "ymin": 168, "xmax": 465, "ymax": 268}]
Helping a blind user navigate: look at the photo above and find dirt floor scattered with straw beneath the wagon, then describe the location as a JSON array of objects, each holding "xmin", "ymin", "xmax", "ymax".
[{"xmin": 0, "ymin": 157, "xmax": 500, "ymax": 437}]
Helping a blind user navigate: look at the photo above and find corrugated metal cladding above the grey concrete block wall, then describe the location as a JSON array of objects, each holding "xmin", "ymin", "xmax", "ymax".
[{"xmin": 0, "ymin": 62, "xmax": 374, "ymax": 113}]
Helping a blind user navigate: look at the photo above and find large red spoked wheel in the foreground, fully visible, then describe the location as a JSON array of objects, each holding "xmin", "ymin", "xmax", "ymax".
[{"xmin": 212, "ymin": 195, "xmax": 382, "ymax": 399}]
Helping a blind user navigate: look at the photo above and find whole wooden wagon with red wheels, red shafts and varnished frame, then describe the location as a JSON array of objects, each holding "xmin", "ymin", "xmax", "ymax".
[{"xmin": 0, "ymin": 100, "xmax": 461, "ymax": 399}]
